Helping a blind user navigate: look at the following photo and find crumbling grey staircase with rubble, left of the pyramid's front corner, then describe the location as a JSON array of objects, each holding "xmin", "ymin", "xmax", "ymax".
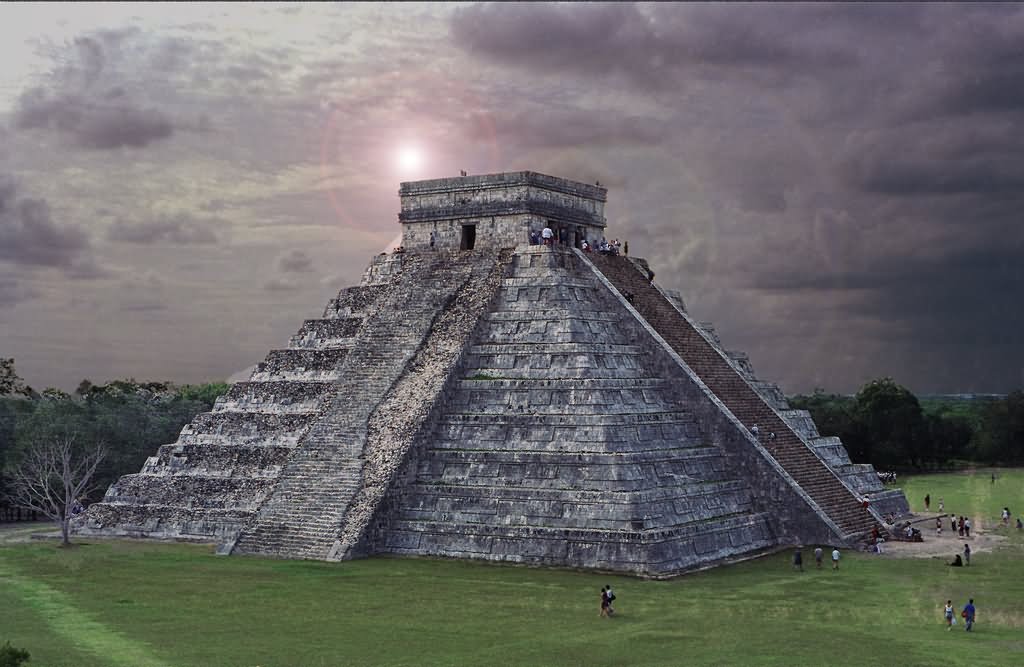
[{"xmin": 226, "ymin": 251, "xmax": 501, "ymax": 559}]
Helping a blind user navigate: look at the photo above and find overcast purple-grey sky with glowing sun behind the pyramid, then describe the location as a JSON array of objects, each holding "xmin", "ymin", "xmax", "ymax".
[{"xmin": 0, "ymin": 3, "xmax": 1024, "ymax": 393}]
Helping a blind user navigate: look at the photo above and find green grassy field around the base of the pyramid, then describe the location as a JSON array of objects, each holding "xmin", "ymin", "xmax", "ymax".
[{"xmin": 0, "ymin": 471, "xmax": 1024, "ymax": 667}]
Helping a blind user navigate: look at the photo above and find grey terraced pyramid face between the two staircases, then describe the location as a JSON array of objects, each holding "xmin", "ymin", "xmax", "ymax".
[{"xmin": 375, "ymin": 246, "xmax": 774, "ymax": 577}]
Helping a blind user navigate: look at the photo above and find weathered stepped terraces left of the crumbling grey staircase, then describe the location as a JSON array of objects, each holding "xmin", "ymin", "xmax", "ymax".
[{"xmin": 75, "ymin": 276, "xmax": 388, "ymax": 541}]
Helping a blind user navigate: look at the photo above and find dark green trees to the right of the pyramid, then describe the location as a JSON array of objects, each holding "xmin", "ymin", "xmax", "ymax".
[{"xmin": 790, "ymin": 378, "xmax": 1024, "ymax": 470}]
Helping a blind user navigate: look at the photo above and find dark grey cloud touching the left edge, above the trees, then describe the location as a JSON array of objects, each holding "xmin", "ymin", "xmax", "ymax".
[{"xmin": 0, "ymin": 176, "xmax": 90, "ymax": 270}]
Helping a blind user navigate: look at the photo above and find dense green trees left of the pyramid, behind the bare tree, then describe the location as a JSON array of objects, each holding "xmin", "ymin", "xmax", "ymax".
[{"xmin": 0, "ymin": 360, "xmax": 228, "ymax": 520}]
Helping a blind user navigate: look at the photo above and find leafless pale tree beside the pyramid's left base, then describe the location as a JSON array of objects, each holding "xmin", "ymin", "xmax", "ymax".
[{"xmin": 8, "ymin": 435, "xmax": 106, "ymax": 546}]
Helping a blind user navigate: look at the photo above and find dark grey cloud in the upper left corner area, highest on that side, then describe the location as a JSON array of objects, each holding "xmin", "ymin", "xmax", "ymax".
[{"xmin": 13, "ymin": 31, "xmax": 175, "ymax": 150}]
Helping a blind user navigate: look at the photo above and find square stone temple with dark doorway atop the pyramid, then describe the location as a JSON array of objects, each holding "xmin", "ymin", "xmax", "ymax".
[{"xmin": 398, "ymin": 171, "xmax": 608, "ymax": 250}]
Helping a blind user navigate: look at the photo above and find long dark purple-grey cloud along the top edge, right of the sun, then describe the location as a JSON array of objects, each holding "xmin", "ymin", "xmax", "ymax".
[{"xmin": 452, "ymin": 3, "xmax": 855, "ymax": 88}]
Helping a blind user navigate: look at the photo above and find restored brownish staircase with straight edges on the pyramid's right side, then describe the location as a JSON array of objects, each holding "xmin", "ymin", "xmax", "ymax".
[{"xmin": 586, "ymin": 253, "xmax": 878, "ymax": 538}]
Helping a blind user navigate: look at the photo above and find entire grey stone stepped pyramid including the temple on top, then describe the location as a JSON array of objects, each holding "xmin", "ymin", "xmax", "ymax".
[{"xmin": 78, "ymin": 171, "xmax": 907, "ymax": 577}]
